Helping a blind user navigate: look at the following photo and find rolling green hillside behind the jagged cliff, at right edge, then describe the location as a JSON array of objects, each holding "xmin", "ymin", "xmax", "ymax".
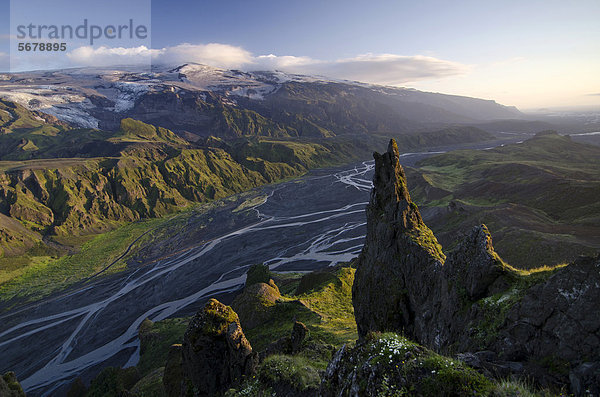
[{"xmin": 408, "ymin": 133, "xmax": 600, "ymax": 267}]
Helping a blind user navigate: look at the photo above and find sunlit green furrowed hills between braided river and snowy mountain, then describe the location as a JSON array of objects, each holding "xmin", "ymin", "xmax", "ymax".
[{"xmin": 0, "ymin": 99, "xmax": 493, "ymax": 258}]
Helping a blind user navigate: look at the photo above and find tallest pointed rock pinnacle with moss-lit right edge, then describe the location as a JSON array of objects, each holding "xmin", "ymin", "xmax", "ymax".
[{"xmin": 352, "ymin": 140, "xmax": 445, "ymax": 337}]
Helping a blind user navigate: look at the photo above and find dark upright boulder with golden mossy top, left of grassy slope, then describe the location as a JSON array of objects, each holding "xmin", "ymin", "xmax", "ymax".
[{"xmin": 182, "ymin": 299, "xmax": 258, "ymax": 396}]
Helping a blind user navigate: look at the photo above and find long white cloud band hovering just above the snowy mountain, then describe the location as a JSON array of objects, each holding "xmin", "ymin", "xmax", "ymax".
[{"xmin": 61, "ymin": 43, "xmax": 470, "ymax": 85}]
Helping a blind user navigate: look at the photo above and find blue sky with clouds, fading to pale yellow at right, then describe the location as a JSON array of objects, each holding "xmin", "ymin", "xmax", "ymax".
[{"xmin": 0, "ymin": 0, "xmax": 600, "ymax": 110}]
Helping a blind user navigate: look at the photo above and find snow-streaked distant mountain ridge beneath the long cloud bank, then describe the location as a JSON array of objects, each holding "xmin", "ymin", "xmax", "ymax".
[{"xmin": 0, "ymin": 64, "xmax": 523, "ymax": 138}]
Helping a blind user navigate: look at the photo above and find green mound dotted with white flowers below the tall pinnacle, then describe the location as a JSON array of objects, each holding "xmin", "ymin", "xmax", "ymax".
[{"xmin": 322, "ymin": 333, "xmax": 538, "ymax": 396}]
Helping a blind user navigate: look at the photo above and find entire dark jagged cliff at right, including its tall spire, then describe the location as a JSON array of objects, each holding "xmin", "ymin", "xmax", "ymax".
[{"xmin": 353, "ymin": 141, "xmax": 600, "ymax": 393}]
